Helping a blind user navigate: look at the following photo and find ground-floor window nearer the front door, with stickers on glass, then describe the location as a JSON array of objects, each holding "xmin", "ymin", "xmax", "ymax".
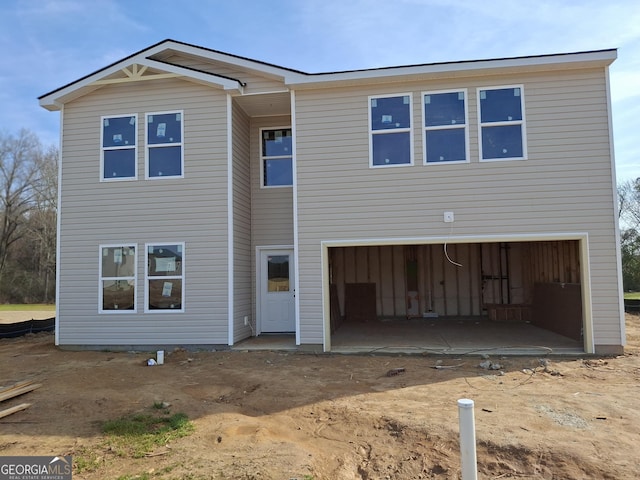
[{"xmin": 145, "ymin": 243, "xmax": 184, "ymax": 312}]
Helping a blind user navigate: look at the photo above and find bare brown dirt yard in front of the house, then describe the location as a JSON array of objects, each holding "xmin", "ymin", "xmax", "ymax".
[{"xmin": 0, "ymin": 315, "xmax": 640, "ymax": 480}]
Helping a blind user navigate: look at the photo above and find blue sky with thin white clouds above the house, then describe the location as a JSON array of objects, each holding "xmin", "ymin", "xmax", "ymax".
[{"xmin": 0, "ymin": 0, "xmax": 640, "ymax": 180}]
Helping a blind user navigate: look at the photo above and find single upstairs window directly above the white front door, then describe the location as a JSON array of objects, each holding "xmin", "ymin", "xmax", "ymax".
[{"xmin": 260, "ymin": 128, "xmax": 293, "ymax": 187}]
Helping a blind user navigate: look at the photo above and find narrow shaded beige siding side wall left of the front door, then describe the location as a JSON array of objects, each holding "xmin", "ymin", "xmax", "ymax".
[{"xmin": 232, "ymin": 104, "xmax": 253, "ymax": 343}]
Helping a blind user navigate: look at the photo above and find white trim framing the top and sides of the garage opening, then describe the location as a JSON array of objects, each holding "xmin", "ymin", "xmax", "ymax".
[{"xmin": 320, "ymin": 232, "xmax": 595, "ymax": 353}]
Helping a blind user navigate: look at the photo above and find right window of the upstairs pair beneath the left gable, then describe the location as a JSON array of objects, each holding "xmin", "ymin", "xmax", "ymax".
[{"xmin": 146, "ymin": 111, "xmax": 184, "ymax": 178}]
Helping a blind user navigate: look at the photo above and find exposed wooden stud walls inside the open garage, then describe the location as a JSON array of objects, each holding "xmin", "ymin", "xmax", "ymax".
[{"xmin": 330, "ymin": 240, "xmax": 580, "ymax": 317}]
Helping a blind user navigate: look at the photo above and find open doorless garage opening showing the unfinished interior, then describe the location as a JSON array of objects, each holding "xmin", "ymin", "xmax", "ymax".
[{"xmin": 328, "ymin": 240, "xmax": 584, "ymax": 353}]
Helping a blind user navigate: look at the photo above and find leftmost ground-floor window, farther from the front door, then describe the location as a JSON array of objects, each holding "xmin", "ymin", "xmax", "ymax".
[{"xmin": 98, "ymin": 244, "xmax": 136, "ymax": 313}]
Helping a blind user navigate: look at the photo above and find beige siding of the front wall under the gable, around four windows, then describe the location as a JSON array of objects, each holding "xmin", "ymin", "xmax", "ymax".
[{"xmin": 58, "ymin": 80, "xmax": 228, "ymax": 345}]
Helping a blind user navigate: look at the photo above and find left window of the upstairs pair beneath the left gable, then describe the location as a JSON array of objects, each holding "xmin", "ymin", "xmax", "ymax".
[{"xmin": 100, "ymin": 114, "xmax": 138, "ymax": 180}]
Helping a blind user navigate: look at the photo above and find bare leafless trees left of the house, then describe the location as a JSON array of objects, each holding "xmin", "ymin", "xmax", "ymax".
[{"xmin": 0, "ymin": 130, "xmax": 58, "ymax": 303}]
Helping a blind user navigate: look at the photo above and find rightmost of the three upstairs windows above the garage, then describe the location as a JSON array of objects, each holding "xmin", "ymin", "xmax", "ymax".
[{"xmin": 478, "ymin": 86, "xmax": 527, "ymax": 161}]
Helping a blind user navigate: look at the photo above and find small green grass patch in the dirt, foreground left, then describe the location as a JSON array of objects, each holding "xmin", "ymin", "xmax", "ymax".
[{"xmin": 102, "ymin": 405, "xmax": 194, "ymax": 458}]
